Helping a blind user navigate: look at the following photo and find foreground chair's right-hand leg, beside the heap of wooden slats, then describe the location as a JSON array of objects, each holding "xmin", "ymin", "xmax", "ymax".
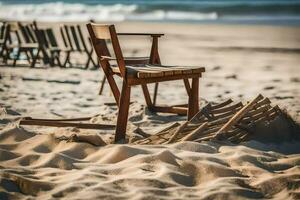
[{"xmin": 188, "ymin": 78, "xmax": 199, "ymax": 120}]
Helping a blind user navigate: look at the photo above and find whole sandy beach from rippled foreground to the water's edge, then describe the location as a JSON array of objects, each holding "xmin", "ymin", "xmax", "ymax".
[{"xmin": 0, "ymin": 22, "xmax": 300, "ymax": 199}]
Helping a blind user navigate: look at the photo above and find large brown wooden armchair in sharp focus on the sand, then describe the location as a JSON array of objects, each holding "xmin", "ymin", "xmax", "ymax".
[{"xmin": 87, "ymin": 23, "xmax": 205, "ymax": 142}]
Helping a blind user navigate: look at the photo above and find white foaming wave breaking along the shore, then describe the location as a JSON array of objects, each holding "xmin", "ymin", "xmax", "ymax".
[{"xmin": 0, "ymin": 2, "xmax": 218, "ymax": 21}]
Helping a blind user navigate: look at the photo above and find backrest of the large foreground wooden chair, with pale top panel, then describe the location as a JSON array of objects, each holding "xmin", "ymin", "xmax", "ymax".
[{"xmin": 87, "ymin": 23, "xmax": 126, "ymax": 77}]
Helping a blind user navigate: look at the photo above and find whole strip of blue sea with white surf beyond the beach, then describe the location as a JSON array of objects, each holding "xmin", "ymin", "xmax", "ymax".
[{"xmin": 0, "ymin": 0, "xmax": 300, "ymax": 26}]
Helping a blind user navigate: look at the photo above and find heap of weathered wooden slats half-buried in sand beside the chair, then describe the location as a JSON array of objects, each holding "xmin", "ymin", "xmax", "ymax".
[{"xmin": 134, "ymin": 95, "xmax": 282, "ymax": 144}]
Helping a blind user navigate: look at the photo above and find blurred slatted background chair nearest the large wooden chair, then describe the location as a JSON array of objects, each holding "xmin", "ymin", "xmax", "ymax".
[{"xmin": 60, "ymin": 25, "xmax": 98, "ymax": 69}]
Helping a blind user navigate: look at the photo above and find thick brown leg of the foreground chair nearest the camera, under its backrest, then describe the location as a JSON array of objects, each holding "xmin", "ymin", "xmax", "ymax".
[{"xmin": 115, "ymin": 81, "xmax": 131, "ymax": 142}]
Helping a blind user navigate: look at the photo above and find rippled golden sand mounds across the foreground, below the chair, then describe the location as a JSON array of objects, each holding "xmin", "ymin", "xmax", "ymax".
[{"xmin": 0, "ymin": 123, "xmax": 300, "ymax": 199}]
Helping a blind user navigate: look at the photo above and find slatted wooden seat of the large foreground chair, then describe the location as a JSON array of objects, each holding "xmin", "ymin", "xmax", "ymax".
[{"xmin": 111, "ymin": 64, "xmax": 205, "ymax": 79}]
